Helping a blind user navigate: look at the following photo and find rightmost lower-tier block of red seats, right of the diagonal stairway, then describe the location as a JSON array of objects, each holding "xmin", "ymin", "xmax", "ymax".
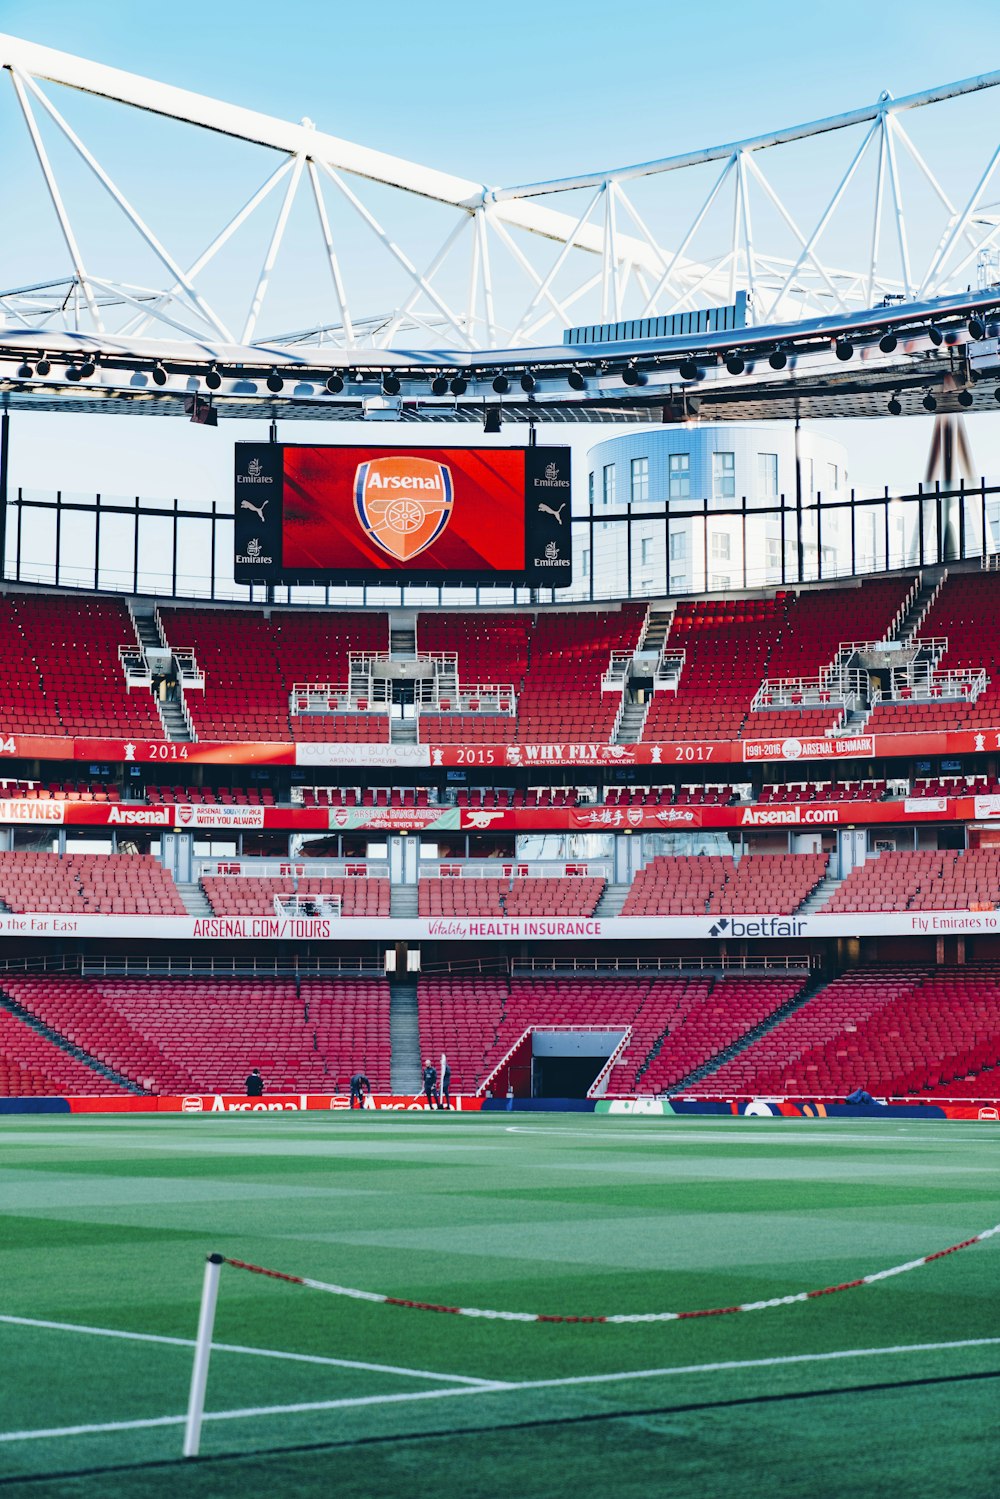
[{"xmin": 701, "ymin": 965, "xmax": 1000, "ymax": 1097}]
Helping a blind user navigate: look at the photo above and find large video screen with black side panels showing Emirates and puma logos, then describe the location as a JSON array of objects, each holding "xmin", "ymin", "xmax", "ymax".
[{"xmin": 234, "ymin": 442, "xmax": 573, "ymax": 588}]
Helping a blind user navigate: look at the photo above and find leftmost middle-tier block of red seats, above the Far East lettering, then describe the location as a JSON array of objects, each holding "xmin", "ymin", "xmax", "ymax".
[{"xmin": 0, "ymin": 851, "xmax": 187, "ymax": 916}]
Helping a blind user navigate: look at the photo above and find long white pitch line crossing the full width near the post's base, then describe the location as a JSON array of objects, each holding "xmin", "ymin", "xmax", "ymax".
[{"xmin": 0, "ymin": 1337, "xmax": 1000, "ymax": 1442}]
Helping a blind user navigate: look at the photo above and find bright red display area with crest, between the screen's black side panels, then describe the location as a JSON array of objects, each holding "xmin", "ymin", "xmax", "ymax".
[{"xmin": 282, "ymin": 447, "xmax": 525, "ymax": 573}]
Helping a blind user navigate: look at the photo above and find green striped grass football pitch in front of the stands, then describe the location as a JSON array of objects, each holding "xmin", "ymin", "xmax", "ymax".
[{"xmin": 0, "ymin": 1112, "xmax": 1000, "ymax": 1499}]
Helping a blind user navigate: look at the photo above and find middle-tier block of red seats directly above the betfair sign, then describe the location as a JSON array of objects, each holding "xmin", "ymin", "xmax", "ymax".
[{"xmin": 622, "ymin": 853, "xmax": 826, "ymax": 916}]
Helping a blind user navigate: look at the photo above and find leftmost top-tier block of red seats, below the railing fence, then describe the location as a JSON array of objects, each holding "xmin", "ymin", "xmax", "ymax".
[{"xmin": 0, "ymin": 594, "xmax": 165, "ymax": 741}]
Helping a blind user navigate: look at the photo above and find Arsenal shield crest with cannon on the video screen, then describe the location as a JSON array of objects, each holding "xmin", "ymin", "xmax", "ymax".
[{"xmin": 354, "ymin": 454, "xmax": 454, "ymax": 562}]
